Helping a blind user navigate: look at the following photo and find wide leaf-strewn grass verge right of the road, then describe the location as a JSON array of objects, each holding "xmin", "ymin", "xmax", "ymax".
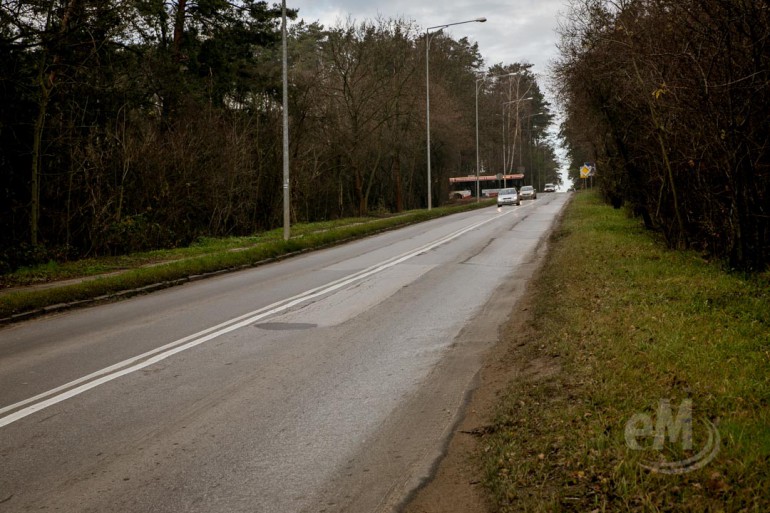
[{"xmin": 481, "ymin": 193, "xmax": 770, "ymax": 512}]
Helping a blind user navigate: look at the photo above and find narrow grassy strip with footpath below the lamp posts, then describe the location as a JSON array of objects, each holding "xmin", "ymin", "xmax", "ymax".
[{"xmin": 0, "ymin": 200, "xmax": 494, "ymax": 320}]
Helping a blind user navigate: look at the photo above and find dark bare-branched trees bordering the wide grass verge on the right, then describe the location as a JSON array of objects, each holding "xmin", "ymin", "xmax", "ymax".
[{"xmin": 555, "ymin": 0, "xmax": 770, "ymax": 271}]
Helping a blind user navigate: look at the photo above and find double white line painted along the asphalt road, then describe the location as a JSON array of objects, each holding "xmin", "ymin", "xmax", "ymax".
[{"xmin": 0, "ymin": 211, "xmax": 512, "ymax": 428}]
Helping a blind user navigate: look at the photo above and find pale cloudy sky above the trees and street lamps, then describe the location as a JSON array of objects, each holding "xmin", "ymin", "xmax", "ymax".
[{"xmin": 286, "ymin": 0, "xmax": 566, "ymax": 81}]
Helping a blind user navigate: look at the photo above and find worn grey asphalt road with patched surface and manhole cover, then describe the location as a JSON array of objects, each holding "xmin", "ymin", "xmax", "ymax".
[{"xmin": 0, "ymin": 194, "xmax": 567, "ymax": 513}]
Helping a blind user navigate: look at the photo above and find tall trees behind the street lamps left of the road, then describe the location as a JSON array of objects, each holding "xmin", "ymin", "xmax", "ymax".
[{"xmin": 0, "ymin": 0, "xmax": 557, "ymax": 272}]
